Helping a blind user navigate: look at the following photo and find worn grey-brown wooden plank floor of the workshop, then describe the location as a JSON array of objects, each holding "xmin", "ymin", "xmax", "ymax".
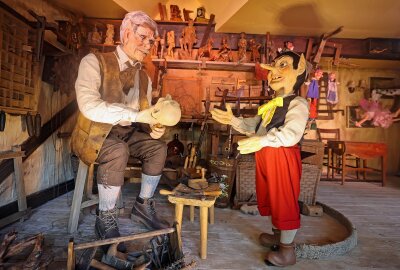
[{"xmin": 0, "ymin": 174, "xmax": 400, "ymax": 270}]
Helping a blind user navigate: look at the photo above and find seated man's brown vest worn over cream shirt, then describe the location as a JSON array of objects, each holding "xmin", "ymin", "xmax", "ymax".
[{"xmin": 71, "ymin": 52, "xmax": 149, "ymax": 165}]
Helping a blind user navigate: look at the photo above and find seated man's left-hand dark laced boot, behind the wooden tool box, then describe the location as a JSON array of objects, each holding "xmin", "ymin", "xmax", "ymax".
[{"xmin": 94, "ymin": 207, "xmax": 126, "ymax": 253}]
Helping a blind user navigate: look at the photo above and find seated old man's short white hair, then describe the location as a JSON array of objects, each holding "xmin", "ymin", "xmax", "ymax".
[{"xmin": 119, "ymin": 11, "xmax": 158, "ymax": 44}]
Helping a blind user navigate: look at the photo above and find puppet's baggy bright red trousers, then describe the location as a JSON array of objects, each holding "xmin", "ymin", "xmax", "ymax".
[{"xmin": 255, "ymin": 145, "xmax": 302, "ymax": 230}]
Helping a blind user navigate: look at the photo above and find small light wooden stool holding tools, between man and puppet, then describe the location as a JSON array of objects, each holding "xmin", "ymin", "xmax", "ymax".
[{"xmin": 162, "ymin": 183, "xmax": 219, "ymax": 259}]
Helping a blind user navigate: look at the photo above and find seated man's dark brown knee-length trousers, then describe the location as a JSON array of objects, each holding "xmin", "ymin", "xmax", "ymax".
[{"xmin": 96, "ymin": 124, "xmax": 167, "ymax": 186}]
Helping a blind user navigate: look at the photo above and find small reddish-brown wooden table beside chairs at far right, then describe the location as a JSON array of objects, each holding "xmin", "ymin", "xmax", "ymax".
[{"xmin": 327, "ymin": 141, "xmax": 387, "ymax": 186}]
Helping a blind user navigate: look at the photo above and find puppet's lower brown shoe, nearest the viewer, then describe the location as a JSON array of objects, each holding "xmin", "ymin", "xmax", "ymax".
[{"xmin": 265, "ymin": 243, "xmax": 296, "ymax": 267}]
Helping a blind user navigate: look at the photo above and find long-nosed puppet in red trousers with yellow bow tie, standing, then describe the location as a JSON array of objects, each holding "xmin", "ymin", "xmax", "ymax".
[{"xmin": 211, "ymin": 51, "xmax": 309, "ymax": 266}]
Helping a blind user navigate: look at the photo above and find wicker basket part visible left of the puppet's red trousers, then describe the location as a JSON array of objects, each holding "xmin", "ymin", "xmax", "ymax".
[{"xmin": 234, "ymin": 154, "xmax": 257, "ymax": 206}]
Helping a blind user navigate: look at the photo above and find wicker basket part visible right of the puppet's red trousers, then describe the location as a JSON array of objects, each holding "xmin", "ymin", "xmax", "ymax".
[{"xmin": 299, "ymin": 163, "xmax": 321, "ymax": 205}]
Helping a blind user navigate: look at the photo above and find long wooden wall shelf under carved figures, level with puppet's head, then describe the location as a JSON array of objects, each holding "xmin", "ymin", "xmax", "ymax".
[{"xmin": 152, "ymin": 59, "xmax": 255, "ymax": 72}]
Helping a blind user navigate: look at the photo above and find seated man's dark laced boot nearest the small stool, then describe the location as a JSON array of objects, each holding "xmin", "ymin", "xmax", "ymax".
[{"xmin": 131, "ymin": 197, "xmax": 170, "ymax": 230}]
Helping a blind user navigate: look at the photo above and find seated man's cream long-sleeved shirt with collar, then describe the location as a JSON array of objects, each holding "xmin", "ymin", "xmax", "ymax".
[{"xmin": 75, "ymin": 46, "xmax": 152, "ymax": 126}]
